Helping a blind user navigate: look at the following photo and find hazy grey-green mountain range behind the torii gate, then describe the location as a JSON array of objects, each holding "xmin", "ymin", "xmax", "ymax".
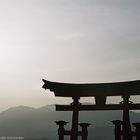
[{"xmin": 0, "ymin": 105, "xmax": 140, "ymax": 140}]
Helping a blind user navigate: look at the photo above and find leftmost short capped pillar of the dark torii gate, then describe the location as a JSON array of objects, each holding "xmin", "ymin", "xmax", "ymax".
[{"xmin": 55, "ymin": 121, "xmax": 68, "ymax": 140}]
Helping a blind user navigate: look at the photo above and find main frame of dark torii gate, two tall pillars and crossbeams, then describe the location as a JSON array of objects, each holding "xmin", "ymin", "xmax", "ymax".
[{"xmin": 43, "ymin": 79, "xmax": 140, "ymax": 140}]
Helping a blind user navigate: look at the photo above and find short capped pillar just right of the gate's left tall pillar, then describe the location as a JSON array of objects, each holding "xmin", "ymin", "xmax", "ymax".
[{"xmin": 79, "ymin": 123, "xmax": 90, "ymax": 140}]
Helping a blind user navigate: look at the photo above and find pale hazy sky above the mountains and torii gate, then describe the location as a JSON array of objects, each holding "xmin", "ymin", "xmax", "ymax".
[{"xmin": 0, "ymin": 0, "xmax": 140, "ymax": 110}]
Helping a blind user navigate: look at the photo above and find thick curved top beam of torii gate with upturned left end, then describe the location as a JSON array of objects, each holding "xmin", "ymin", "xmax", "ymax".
[{"xmin": 42, "ymin": 79, "xmax": 140, "ymax": 97}]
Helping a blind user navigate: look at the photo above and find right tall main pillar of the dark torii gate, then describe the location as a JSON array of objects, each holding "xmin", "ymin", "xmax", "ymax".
[{"xmin": 122, "ymin": 95, "xmax": 132, "ymax": 140}]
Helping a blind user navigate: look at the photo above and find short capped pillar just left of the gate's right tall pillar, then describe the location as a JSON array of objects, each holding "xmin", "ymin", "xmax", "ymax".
[{"xmin": 111, "ymin": 120, "xmax": 122, "ymax": 140}]
